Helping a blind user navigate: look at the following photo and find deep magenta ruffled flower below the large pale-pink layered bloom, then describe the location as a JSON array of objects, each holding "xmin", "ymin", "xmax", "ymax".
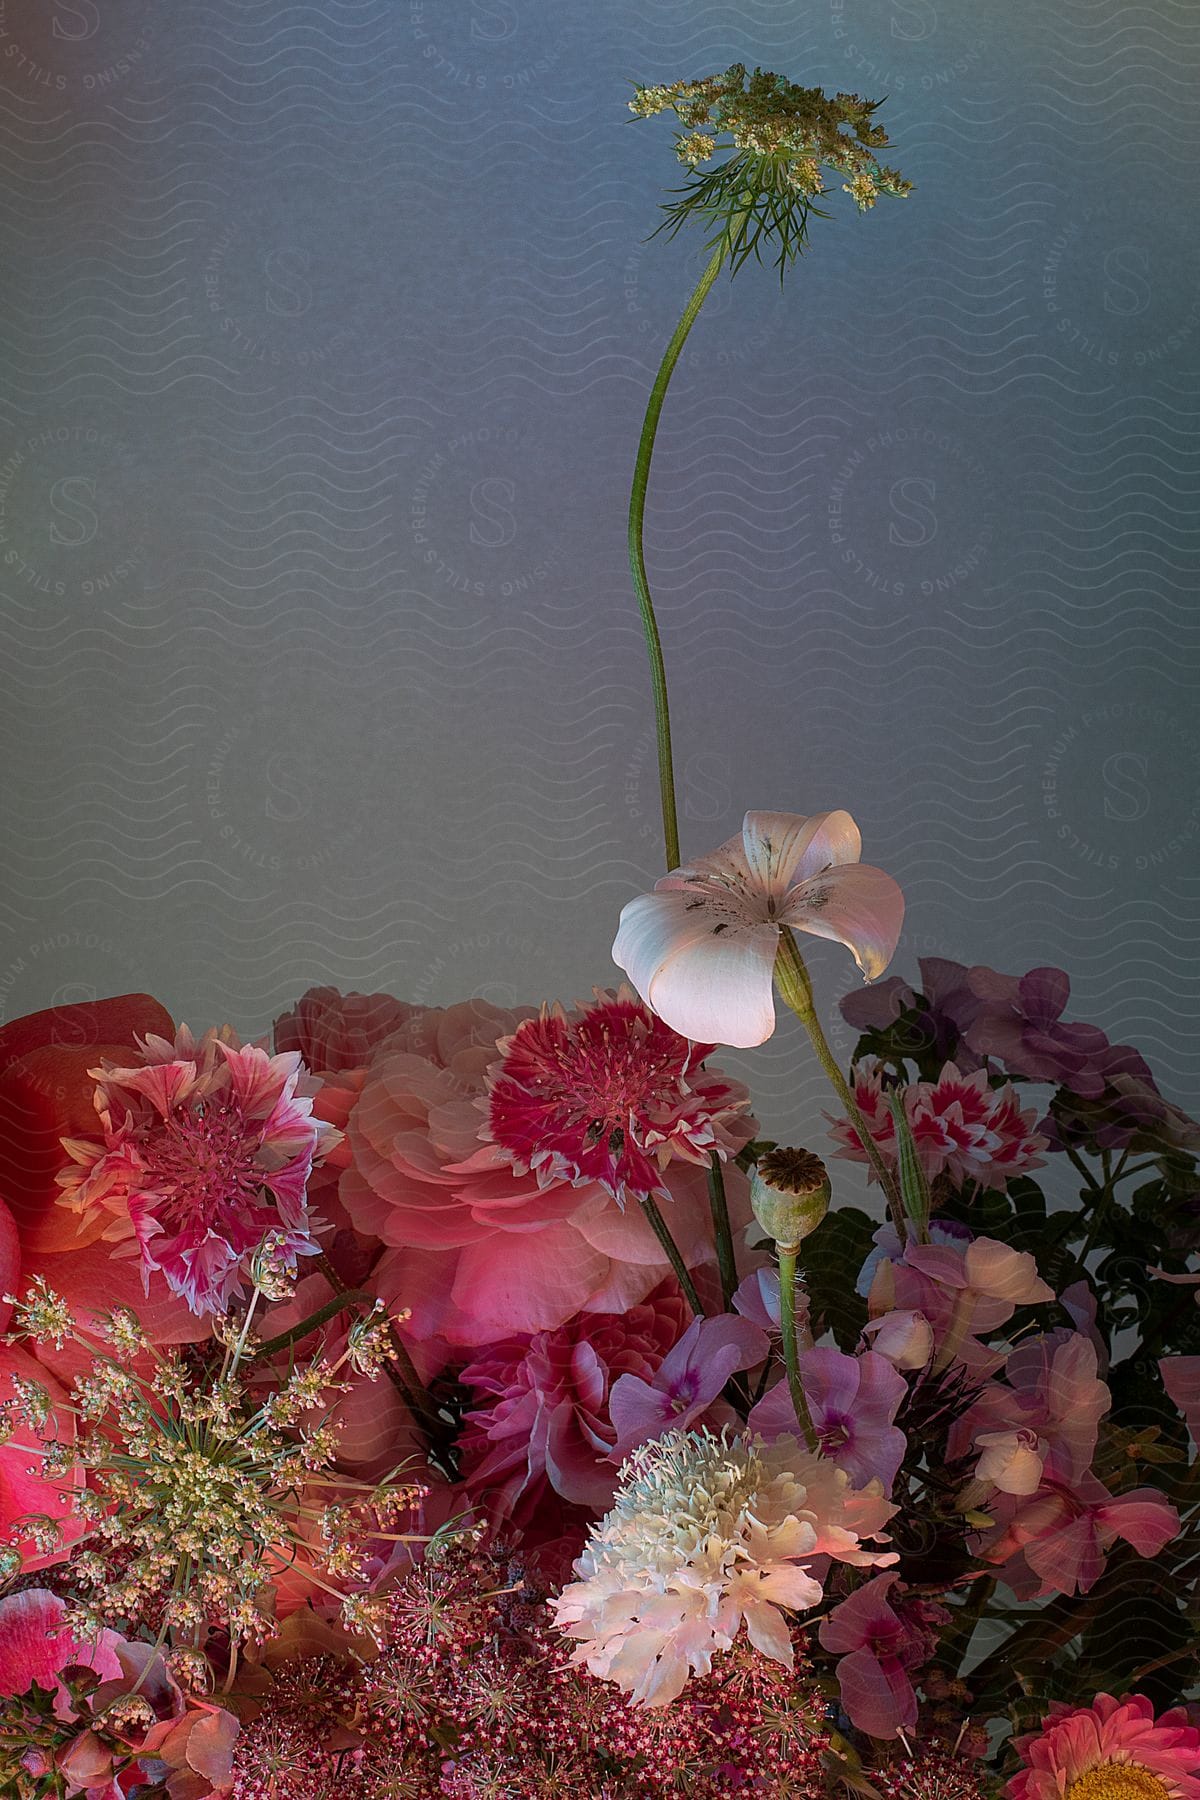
[{"xmin": 459, "ymin": 1283, "xmax": 690, "ymax": 1519}]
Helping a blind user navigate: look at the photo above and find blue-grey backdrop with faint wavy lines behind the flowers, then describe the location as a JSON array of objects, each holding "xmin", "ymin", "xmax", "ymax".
[{"xmin": 0, "ymin": 0, "xmax": 1200, "ymax": 1166}]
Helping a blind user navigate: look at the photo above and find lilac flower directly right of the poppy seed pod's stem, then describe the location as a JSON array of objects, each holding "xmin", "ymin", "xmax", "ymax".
[{"xmin": 748, "ymin": 1345, "xmax": 909, "ymax": 1489}]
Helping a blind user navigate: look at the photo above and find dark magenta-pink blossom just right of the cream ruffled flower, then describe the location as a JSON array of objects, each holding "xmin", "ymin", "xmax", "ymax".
[{"xmin": 817, "ymin": 1573, "xmax": 936, "ymax": 1737}]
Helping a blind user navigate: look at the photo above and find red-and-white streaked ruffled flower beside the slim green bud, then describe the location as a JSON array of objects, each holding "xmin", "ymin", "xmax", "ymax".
[{"xmin": 826, "ymin": 1058, "xmax": 1045, "ymax": 1188}]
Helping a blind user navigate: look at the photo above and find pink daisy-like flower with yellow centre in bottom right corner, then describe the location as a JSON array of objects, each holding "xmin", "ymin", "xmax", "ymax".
[{"xmin": 1007, "ymin": 1694, "xmax": 1200, "ymax": 1800}]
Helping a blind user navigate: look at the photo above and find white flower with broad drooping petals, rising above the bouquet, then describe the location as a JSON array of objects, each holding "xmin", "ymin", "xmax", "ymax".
[{"xmin": 612, "ymin": 812, "xmax": 905, "ymax": 1049}]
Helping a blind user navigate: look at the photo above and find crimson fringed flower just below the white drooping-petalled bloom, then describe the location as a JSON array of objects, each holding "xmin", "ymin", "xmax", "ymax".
[{"xmin": 488, "ymin": 988, "xmax": 750, "ymax": 1206}]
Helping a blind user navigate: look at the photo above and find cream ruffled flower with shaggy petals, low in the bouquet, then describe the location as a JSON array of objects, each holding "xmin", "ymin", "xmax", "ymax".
[{"xmin": 552, "ymin": 1431, "xmax": 896, "ymax": 1706}]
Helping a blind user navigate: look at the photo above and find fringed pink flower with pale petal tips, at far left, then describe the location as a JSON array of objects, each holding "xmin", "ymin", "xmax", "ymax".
[{"xmin": 59, "ymin": 1026, "xmax": 335, "ymax": 1314}]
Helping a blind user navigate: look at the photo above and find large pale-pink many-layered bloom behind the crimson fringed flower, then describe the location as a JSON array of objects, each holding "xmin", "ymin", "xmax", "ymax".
[{"xmin": 332, "ymin": 1001, "xmax": 750, "ymax": 1346}]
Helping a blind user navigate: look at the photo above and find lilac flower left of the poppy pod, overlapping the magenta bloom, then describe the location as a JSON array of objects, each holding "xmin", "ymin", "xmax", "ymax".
[{"xmin": 608, "ymin": 1312, "xmax": 768, "ymax": 1460}]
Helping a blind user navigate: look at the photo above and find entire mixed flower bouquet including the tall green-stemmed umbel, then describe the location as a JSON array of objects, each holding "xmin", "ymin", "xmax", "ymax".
[{"xmin": 0, "ymin": 67, "xmax": 1200, "ymax": 1800}]
